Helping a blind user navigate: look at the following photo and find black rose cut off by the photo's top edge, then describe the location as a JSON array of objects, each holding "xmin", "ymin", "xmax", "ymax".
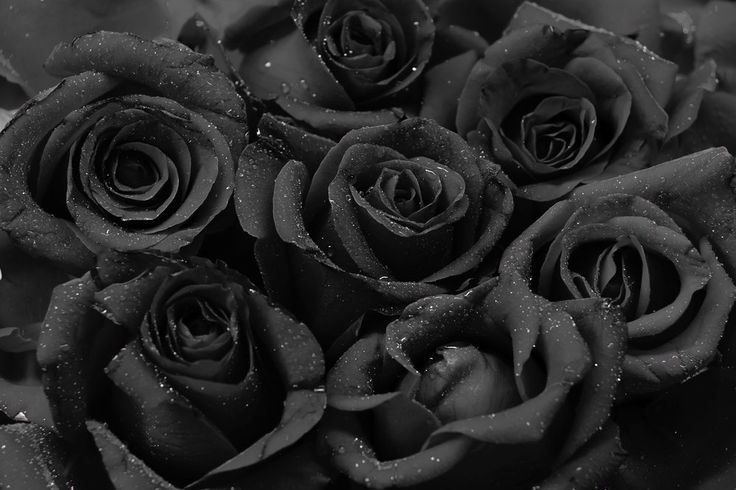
[{"xmin": 223, "ymin": 0, "xmax": 487, "ymax": 138}]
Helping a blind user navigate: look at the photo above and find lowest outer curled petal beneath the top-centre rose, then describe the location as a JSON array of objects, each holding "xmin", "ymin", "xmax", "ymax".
[{"xmin": 277, "ymin": 95, "xmax": 404, "ymax": 138}]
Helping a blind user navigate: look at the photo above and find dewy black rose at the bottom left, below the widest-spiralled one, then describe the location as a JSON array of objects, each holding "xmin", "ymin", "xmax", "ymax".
[{"xmin": 38, "ymin": 254, "xmax": 325, "ymax": 485}]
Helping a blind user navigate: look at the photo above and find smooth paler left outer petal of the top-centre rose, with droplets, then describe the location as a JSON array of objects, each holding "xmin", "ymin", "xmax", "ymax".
[{"xmin": 239, "ymin": 27, "xmax": 355, "ymax": 111}]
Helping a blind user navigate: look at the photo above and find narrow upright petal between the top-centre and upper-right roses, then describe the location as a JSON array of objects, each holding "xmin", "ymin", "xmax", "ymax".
[{"xmin": 419, "ymin": 51, "xmax": 478, "ymax": 130}]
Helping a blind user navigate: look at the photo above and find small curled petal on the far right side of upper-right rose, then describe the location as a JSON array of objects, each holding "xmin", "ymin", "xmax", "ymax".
[{"xmin": 666, "ymin": 60, "xmax": 718, "ymax": 141}]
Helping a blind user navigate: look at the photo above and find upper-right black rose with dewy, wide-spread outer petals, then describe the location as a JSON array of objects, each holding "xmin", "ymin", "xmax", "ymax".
[{"xmin": 456, "ymin": 3, "xmax": 715, "ymax": 201}]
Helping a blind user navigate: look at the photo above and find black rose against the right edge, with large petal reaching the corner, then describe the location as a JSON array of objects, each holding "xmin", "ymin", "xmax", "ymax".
[{"xmin": 499, "ymin": 149, "xmax": 736, "ymax": 394}]
